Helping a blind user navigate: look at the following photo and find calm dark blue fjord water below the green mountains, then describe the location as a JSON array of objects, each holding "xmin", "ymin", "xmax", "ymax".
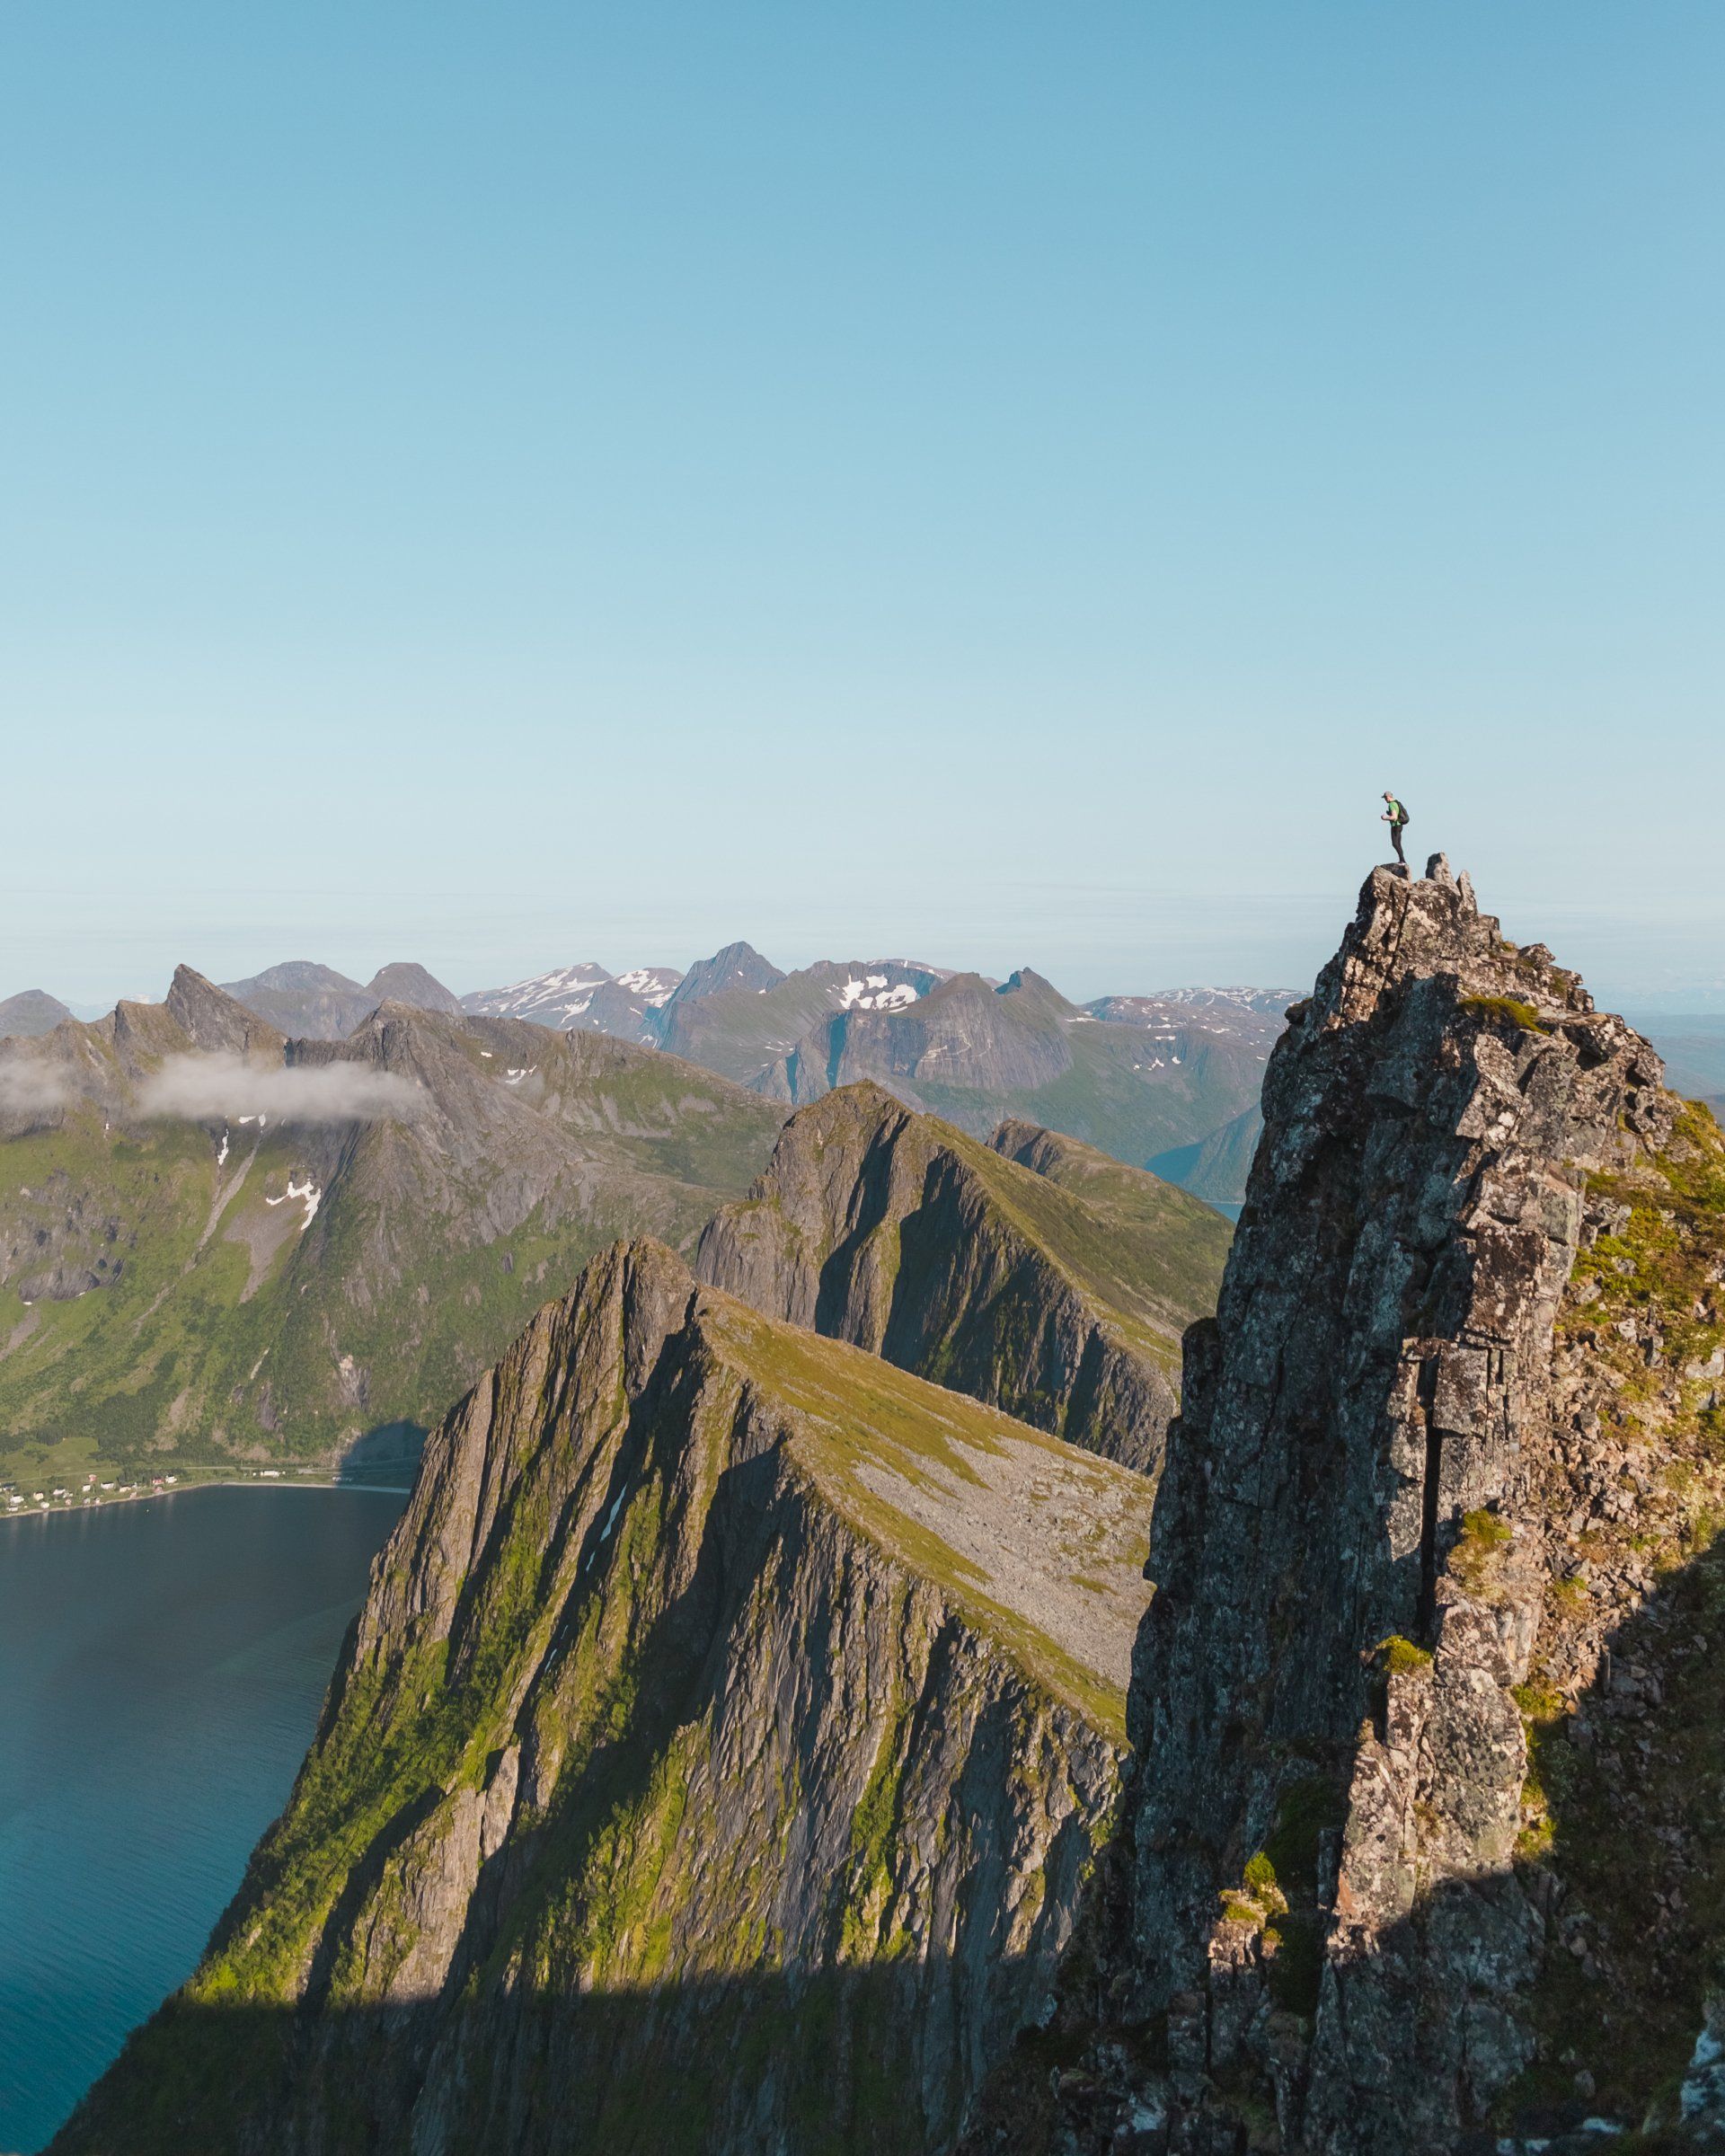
[{"xmin": 0, "ymin": 1488, "xmax": 403, "ymax": 2152}]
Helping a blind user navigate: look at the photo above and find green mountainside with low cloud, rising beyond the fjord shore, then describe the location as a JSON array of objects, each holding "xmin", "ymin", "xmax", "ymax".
[{"xmin": 0, "ymin": 975, "xmax": 778, "ymax": 1479}]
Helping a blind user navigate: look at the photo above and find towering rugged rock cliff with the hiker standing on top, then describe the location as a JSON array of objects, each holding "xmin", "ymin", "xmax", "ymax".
[{"xmin": 961, "ymin": 861, "xmax": 1725, "ymax": 2156}]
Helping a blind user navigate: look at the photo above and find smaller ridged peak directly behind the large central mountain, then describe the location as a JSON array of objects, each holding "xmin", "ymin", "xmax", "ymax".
[{"xmin": 696, "ymin": 1084, "xmax": 1227, "ymax": 1472}]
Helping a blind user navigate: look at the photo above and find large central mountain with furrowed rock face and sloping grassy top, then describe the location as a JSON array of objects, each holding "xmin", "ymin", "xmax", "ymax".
[{"xmin": 54, "ymin": 1244, "xmax": 1149, "ymax": 2156}]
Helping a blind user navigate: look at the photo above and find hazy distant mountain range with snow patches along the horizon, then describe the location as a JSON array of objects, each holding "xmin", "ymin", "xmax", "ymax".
[{"xmin": 0, "ymin": 942, "xmax": 1294, "ymax": 1209}]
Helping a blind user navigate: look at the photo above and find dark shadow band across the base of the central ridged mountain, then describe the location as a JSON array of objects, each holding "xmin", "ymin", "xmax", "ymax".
[{"xmin": 48, "ymin": 1957, "xmax": 1039, "ymax": 2156}]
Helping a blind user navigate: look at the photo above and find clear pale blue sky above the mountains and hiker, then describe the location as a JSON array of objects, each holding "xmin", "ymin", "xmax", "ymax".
[{"xmin": 0, "ymin": 0, "xmax": 1725, "ymax": 1007}]
